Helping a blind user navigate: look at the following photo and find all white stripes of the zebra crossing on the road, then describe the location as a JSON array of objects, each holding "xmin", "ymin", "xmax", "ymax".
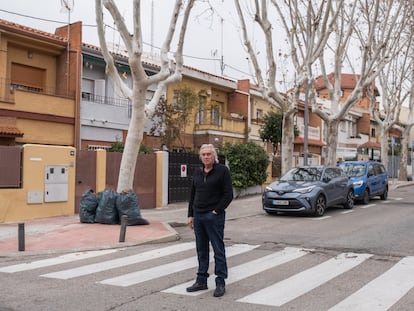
[{"xmin": 0, "ymin": 242, "xmax": 414, "ymax": 311}]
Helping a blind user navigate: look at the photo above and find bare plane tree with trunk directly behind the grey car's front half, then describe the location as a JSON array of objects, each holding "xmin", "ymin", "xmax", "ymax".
[{"xmin": 234, "ymin": 0, "xmax": 344, "ymax": 173}]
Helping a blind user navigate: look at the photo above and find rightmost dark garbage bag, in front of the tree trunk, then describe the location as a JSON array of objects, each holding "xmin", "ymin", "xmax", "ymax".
[{"xmin": 116, "ymin": 190, "xmax": 149, "ymax": 226}]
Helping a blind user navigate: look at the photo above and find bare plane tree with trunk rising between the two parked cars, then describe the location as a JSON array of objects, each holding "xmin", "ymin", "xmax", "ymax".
[{"xmin": 312, "ymin": 0, "xmax": 408, "ymax": 165}]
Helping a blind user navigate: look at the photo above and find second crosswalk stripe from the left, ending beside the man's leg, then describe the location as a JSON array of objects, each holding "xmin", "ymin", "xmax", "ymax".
[{"xmin": 41, "ymin": 242, "xmax": 195, "ymax": 280}]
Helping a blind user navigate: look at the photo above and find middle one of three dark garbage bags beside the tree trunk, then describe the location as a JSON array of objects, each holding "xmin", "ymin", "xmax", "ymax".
[{"xmin": 95, "ymin": 189, "xmax": 119, "ymax": 225}]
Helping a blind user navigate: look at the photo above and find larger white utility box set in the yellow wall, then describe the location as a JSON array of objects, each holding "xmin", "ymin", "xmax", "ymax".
[{"xmin": 45, "ymin": 165, "xmax": 69, "ymax": 202}]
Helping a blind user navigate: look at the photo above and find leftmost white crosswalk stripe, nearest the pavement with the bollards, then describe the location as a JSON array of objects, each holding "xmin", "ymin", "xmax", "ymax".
[{"xmin": 0, "ymin": 249, "xmax": 117, "ymax": 273}]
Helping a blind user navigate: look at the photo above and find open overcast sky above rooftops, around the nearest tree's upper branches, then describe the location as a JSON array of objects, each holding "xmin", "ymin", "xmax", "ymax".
[{"xmin": 0, "ymin": 0, "xmax": 262, "ymax": 80}]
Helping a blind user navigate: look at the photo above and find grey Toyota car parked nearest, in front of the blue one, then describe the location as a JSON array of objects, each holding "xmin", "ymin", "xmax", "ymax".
[{"xmin": 262, "ymin": 166, "xmax": 354, "ymax": 216}]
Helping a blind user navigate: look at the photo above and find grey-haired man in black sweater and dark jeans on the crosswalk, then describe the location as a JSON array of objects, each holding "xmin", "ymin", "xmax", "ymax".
[{"xmin": 187, "ymin": 144, "xmax": 233, "ymax": 297}]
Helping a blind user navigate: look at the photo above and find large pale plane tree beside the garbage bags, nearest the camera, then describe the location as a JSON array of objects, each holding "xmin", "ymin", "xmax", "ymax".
[{"xmin": 95, "ymin": 0, "xmax": 195, "ymax": 192}]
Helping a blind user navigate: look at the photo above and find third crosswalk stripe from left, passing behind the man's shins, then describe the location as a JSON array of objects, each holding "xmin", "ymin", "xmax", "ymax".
[{"xmin": 98, "ymin": 244, "xmax": 259, "ymax": 287}]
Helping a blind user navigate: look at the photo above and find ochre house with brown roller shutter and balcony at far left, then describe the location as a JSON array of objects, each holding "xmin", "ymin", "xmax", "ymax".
[{"xmin": 0, "ymin": 20, "xmax": 81, "ymax": 146}]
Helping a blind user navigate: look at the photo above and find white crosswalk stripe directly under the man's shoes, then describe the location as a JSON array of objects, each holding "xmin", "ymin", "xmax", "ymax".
[{"xmin": 162, "ymin": 247, "xmax": 308, "ymax": 296}]
